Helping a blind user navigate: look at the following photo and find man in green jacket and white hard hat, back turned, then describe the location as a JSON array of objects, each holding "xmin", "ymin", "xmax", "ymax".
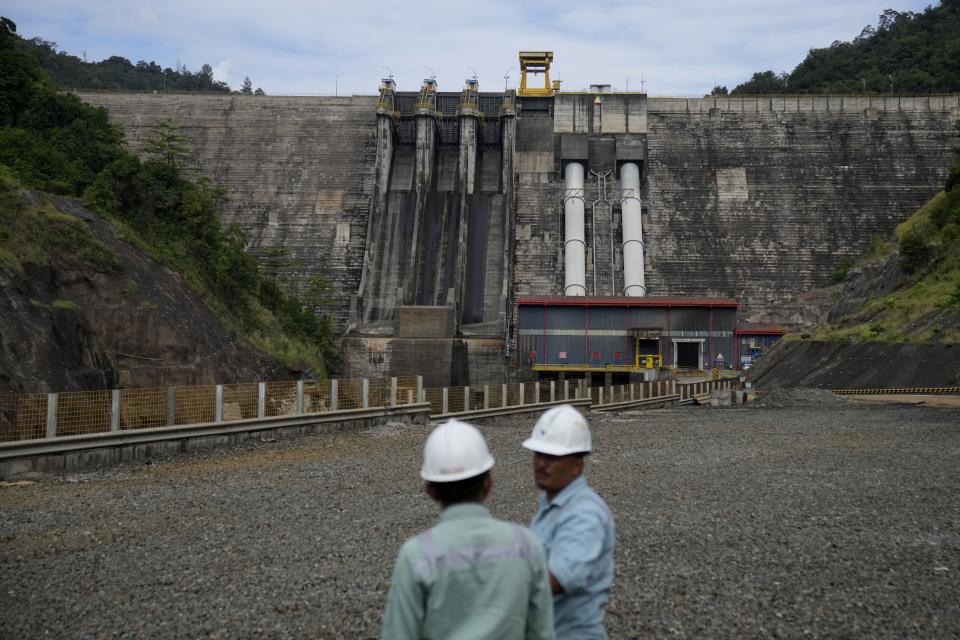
[{"xmin": 381, "ymin": 420, "xmax": 556, "ymax": 640}]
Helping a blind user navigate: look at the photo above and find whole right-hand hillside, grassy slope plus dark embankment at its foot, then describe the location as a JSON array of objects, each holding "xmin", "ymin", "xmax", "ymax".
[{"xmin": 749, "ymin": 172, "xmax": 960, "ymax": 389}]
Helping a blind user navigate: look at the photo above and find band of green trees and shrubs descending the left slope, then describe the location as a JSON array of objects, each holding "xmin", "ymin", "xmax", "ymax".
[{"xmin": 0, "ymin": 18, "xmax": 336, "ymax": 375}]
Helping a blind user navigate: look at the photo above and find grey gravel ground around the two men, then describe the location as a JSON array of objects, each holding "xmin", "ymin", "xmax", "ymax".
[{"xmin": 0, "ymin": 398, "xmax": 960, "ymax": 639}]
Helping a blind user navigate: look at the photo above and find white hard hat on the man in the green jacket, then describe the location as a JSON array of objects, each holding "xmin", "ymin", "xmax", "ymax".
[{"xmin": 420, "ymin": 420, "xmax": 493, "ymax": 482}]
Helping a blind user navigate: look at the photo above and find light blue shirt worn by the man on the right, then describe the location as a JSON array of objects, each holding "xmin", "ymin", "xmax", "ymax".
[{"xmin": 530, "ymin": 476, "xmax": 615, "ymax": 640}]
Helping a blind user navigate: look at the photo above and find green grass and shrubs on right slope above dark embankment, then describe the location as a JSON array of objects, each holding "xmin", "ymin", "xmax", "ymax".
[{"xmin": 816, "ymin": 149, "xmax": 960, "ymax": 343}]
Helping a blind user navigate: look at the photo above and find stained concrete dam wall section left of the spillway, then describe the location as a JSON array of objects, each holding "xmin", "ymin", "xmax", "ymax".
[{"xmin": 79, "ymin": 93, "xmax": 377, "ymax": 326}]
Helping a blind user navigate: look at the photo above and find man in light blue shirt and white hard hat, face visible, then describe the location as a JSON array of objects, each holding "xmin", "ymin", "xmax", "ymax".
[{"xmin": 523, "ymin": 405, "xmax": 615, "ymax": 640}]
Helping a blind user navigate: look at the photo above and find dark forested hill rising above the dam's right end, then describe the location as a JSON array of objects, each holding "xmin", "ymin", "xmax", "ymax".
[{"xmin": 713, "ymin": 0, "xmax": 960, "ymax": 95}]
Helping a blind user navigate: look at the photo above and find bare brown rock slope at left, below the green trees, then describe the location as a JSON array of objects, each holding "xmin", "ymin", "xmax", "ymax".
[{"xmin": 0, "ymin": 190, "xmax": 291, "ymax": 392}]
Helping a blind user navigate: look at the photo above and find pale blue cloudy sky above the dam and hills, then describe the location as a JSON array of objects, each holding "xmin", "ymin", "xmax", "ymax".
[{"xmin": 0, "ymin": 0, "xmax": 937, "ymax": 95}]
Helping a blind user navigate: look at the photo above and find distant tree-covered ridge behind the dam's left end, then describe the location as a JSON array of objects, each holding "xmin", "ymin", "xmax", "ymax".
[{"xmin": 16, "ymin": 25, "xmax": 264, "ymax": 95}]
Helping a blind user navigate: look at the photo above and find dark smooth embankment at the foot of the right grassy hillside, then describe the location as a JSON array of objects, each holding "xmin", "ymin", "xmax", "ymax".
[{"xmin": 748, "ymin": 341, "xmax": 960, "ymax": 389}]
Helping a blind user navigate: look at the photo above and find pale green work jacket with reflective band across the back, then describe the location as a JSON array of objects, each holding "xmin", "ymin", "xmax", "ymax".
[{"xmin": 381, "ymin": 503, "xmax": 556, "ymax": 640}]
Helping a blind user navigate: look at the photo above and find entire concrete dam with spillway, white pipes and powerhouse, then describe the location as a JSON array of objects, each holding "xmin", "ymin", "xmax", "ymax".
[{"xmin": 80, "ymin": 52, "xmax": 960, "ymax": 385}]
